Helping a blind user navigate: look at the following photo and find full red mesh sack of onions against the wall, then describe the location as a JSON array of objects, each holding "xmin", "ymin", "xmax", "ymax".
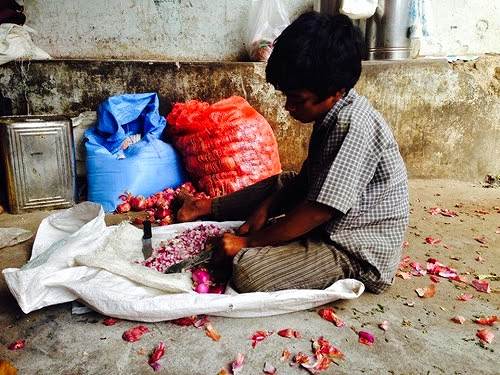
[{"xmin": 167, "ymin": 96, "xmax": 281, "ymax": 197}]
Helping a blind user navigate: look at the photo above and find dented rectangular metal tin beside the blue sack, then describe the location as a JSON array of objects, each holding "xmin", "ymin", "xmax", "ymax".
[{"xmin": 0, "ymin": 116, "xmax": 75, "ymax": 214}]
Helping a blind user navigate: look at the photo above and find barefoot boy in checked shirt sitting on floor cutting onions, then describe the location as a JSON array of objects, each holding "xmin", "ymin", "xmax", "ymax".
[{"xmin": 178, "ymin": 12, "xmax": 408, "ymax": 293}]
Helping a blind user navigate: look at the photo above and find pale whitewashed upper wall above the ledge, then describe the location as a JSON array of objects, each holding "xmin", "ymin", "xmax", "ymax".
[{"xmin": 24, "ymin": 0, "xmax": 500, "ymax": 61}]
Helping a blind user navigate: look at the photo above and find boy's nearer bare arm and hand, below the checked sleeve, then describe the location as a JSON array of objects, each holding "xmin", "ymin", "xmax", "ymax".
[{"xmin": 223, "ymin": 200, "xmax": 342, "ymax": 256}]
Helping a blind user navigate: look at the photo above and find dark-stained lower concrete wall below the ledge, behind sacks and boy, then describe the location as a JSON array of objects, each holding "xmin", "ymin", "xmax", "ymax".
[{"xmin": 0, "ymin": 57, "xmax": 500, "ymax": 179}]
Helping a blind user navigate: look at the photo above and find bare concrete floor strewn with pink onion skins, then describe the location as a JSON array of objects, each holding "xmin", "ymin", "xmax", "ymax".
[{"xmin": 0, "ymin": 180, "xmax": 500, "ymax": 375}]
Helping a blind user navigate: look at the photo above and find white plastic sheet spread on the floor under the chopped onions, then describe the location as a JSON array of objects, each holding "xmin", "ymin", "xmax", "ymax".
[{"xmin": 2, "ymin": 202, "xmax": 364, "ymax": 322}]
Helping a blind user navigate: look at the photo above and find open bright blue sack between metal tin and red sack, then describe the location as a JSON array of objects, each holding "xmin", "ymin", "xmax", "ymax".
[{"xmin": 85, "ymin": 93, "xmax": 185, "ymax": 212}]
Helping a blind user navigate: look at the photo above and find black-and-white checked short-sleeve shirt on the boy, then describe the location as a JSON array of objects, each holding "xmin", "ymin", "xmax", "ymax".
[{"xmin": 301, "ymin": 89, "xmax": 409, "ymax": 292}]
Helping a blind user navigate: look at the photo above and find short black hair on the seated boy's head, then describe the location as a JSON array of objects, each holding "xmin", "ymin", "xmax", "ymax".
[{"xmin": 266, "ymin": 12, "xmax": 364, "ymax": 100}]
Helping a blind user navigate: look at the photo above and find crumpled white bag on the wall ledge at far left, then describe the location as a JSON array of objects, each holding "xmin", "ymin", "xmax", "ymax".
[{"xmin": 0, "ymin": 23, "xmax": 51, "ymax": 65}]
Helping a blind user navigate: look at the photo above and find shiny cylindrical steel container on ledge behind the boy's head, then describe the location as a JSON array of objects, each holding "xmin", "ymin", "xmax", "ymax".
[{"xmin": 365, "ymin": 0, "xmax": 410, "ymax": 60}]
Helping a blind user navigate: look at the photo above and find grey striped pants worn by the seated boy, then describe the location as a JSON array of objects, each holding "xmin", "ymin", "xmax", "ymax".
[{"xmin": 212, "ymin": 173, "xmax": 358, "ymax": 293}]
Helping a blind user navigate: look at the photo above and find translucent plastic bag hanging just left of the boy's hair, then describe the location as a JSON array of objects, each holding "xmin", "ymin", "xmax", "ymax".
[{"xmin": 247, "ymin": 0, "xmax": 290, "ymax": 62}]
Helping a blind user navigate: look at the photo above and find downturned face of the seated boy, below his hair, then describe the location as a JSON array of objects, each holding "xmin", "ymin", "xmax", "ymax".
[{"xmin": 284, "ymin": 89, "xmax": 341, "ymax": 123}]
